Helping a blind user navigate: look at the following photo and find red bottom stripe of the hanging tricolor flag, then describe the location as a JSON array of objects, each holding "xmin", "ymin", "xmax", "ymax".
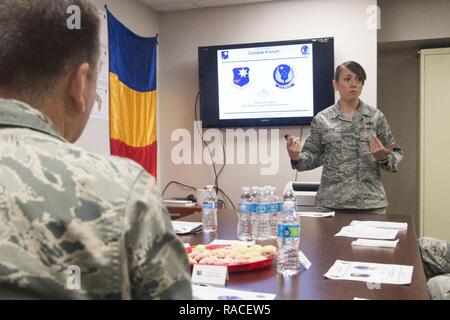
[{"xmin": 110, "ymin": 139, "xmax": 157, "ymax": 178}]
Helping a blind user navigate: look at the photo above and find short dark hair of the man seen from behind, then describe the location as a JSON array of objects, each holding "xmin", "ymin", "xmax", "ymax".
[{"xmin": 0, "ymin": 0, "xmax": 100, "ymax": 93}]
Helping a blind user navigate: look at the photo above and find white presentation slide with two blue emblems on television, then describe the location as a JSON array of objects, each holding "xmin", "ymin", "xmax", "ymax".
[{"xmin": 217, "ymin": 43, "xmax": 314, "ymax": 120}]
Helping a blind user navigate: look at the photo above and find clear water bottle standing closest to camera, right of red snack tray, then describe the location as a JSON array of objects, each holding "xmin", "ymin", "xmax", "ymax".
[{"xmin": 277, "ymin": 198, "xmax": 300, "ymax": 277}]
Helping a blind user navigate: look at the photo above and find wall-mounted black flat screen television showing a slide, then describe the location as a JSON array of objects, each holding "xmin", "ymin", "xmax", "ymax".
[{"xmin": 198, "ymin": 37, "xmax": 334, "ymax": 128}]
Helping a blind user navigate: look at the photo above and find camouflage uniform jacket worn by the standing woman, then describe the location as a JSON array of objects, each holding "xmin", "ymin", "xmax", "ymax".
[{"xmin": 291, "ymin": 101, "xmax": 403, "ymax": 209}]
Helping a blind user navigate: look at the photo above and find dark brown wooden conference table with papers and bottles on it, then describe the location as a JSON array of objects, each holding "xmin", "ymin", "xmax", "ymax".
[{"xmin": 179, "ymin": 210, "xmax": 429, "ymax": 300}]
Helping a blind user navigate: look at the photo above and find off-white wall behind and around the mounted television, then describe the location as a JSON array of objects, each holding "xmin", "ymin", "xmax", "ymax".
[{"xmin": 158, "ymin": 0, "xmax": 377, "ymax": 201}]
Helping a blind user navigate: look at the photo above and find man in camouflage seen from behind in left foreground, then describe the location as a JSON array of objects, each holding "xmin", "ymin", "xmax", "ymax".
[{"xmin": 0, "ymin": 0, "xmax": 192, "ymax": 299}]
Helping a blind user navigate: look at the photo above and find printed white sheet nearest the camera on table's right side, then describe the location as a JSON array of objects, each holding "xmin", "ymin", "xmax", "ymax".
[{"xmin": 325, "ymin": 260, "xmax": 413, "ymax": 285}]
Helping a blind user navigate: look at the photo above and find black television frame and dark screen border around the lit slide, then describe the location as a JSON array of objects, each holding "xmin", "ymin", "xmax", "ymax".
[{"xmin": 198, "ymin": 37, "xmax": 335, "ymax": 128}]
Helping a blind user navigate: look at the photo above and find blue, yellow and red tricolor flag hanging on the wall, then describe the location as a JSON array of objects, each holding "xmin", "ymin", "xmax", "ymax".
[{"xmin": 108, "ymin": 11, "xmax": 157, "ymax": 177}]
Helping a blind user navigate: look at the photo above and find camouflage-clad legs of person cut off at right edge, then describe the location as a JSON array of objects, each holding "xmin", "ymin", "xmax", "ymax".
[{"xmin": 419, "ymin": 238, "xmax": 450, "ymax": 300}]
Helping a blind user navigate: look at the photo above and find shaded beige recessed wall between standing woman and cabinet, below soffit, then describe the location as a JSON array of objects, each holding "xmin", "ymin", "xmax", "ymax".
[{"xmin": 378, "ymin": 47, "xmax": 419, "ymax": 231}]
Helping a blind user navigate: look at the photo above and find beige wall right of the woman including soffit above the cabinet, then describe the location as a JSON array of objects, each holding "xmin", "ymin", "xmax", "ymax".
[{"xmin": 378, "ymin": 0, "xmax": 450, "ymax": 228}]
